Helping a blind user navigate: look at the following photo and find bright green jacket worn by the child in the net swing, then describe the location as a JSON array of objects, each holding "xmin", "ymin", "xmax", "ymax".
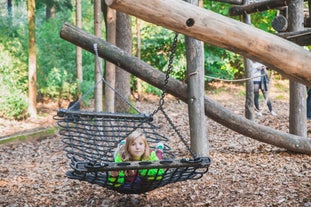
[{"xmin": 108, "ymin": 151, "xmax": 164, "ymax": 187}]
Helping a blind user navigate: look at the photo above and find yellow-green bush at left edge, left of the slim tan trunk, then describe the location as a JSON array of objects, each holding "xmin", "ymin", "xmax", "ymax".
[{"xmin": 0, "ymin": 32, "xmax": 28, "ymax": 120}]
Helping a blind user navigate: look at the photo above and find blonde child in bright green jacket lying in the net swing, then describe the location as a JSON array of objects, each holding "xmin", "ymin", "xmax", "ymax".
[{"xmin": 108, "ymin": 130, "xmax": 164, "ymax": 187}]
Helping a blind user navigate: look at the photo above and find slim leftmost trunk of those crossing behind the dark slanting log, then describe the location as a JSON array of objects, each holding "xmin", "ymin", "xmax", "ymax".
[{"xmin": 76, "ymin": 0, "xmax": 83, "ymax": 88}]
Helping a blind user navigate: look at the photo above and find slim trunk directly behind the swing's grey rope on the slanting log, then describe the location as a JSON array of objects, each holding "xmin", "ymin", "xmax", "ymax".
[{"xmin": 94, "ymin": 0, "xmax": 103, "ymax": 111}]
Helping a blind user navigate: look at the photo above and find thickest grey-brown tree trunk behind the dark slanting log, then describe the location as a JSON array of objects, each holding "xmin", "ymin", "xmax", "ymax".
[{"xmin": 115, "ymin": 12, "xmax": 132, "ymax": 112}]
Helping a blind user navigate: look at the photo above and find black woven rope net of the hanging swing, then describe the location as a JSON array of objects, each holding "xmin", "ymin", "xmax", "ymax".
[{"xmin": 54, "ymin": 106, "xmax": 210, "ymax": 194}]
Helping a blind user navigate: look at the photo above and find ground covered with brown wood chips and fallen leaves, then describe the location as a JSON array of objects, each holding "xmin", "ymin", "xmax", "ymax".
[{"xmin": 0, "ymin": 82, "xmax": 311, "ymax": 207}]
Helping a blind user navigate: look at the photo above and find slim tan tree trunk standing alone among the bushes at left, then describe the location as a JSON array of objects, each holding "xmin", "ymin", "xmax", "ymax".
[{"xmin": 28, "ymin": 0, "xmax": 37, "ymax": 118}]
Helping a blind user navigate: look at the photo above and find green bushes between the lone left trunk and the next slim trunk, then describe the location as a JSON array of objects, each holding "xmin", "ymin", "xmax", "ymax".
[{"xmin": 37, "ymin": 13, "xmax": 76, "ymax": 98}]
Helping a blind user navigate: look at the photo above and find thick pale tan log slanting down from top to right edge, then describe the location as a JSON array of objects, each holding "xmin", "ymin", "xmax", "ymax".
[{"xmin": 106, "ymin": 0, "xmax": 311, "ymax": 86}]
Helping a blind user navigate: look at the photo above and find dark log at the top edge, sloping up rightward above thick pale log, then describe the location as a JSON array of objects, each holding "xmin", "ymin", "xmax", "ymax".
[{"xmin": 228, "ymin": 0, "xmax": 287, "ymax": 16}]
